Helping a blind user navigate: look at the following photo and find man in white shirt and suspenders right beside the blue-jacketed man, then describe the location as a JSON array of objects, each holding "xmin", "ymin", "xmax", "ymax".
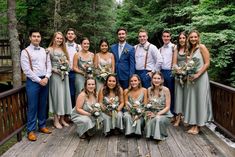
[{"xmin": 135, "ymin": 29, "xmax": 163, "ymax": 88}]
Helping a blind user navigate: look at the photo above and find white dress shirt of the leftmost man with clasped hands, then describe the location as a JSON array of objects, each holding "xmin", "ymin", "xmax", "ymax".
[{"xmin": 20, "ymin": 44, "xmax": 51, "ymax": 83}]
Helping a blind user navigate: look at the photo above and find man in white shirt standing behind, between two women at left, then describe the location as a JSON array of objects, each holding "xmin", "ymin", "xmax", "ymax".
[{"xmin": 66, "ymin": 28, "xmax": 82, "ymax": 107}]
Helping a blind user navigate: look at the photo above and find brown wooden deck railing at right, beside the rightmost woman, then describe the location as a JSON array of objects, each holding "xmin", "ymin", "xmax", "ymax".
[{"xmin": 210, "ymin": 81, "xmax": 235, "ymax": 140}]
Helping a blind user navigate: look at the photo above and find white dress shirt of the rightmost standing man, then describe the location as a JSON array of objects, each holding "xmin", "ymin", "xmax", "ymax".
[{"xmin": 160, "ymin": 42, "xmax": 175, "ymax": 70}]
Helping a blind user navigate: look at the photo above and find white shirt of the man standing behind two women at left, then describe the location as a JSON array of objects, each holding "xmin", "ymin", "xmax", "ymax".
[{"xmin": 66, "ymin": 42, "xmax": 82, "ymax": 69}]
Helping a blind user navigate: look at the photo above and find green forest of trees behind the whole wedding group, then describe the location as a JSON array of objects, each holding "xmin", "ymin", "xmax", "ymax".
[{"xmin": 0, "ymin": 0, "xmax": 235, "ymax": 87}]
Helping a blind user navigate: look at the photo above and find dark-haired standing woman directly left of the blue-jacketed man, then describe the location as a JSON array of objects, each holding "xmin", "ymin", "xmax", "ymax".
[{"xmin": 94, "ymin": 39, "xmax": 115, "ymax": 91}]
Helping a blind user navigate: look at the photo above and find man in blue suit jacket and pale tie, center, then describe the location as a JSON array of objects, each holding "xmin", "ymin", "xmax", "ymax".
[{"xmin": 111, "ymin": 27, "xmax": 135, "ymax": 89}]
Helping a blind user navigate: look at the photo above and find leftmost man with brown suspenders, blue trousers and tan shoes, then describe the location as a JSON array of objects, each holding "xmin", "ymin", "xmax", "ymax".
[{"xmin": 21, "ymin": 30, "xmax": 51, "ymax": 141}]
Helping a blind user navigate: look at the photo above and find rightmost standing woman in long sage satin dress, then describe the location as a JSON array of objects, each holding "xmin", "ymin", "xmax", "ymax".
[{"xmin": 184, "ymin": 30, "xmax": 213, "ymax": 134}]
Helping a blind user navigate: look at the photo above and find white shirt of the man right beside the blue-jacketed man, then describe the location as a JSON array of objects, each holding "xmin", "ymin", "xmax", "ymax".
[{"xmin": 135, "ymin": 42, "xmax": 162, "ymax": 72}]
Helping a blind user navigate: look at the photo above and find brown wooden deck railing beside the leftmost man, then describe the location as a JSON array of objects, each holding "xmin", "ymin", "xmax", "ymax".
[{"xmin": 0, "ymin": 86, "xmax": 27, "ymax": 145}]
